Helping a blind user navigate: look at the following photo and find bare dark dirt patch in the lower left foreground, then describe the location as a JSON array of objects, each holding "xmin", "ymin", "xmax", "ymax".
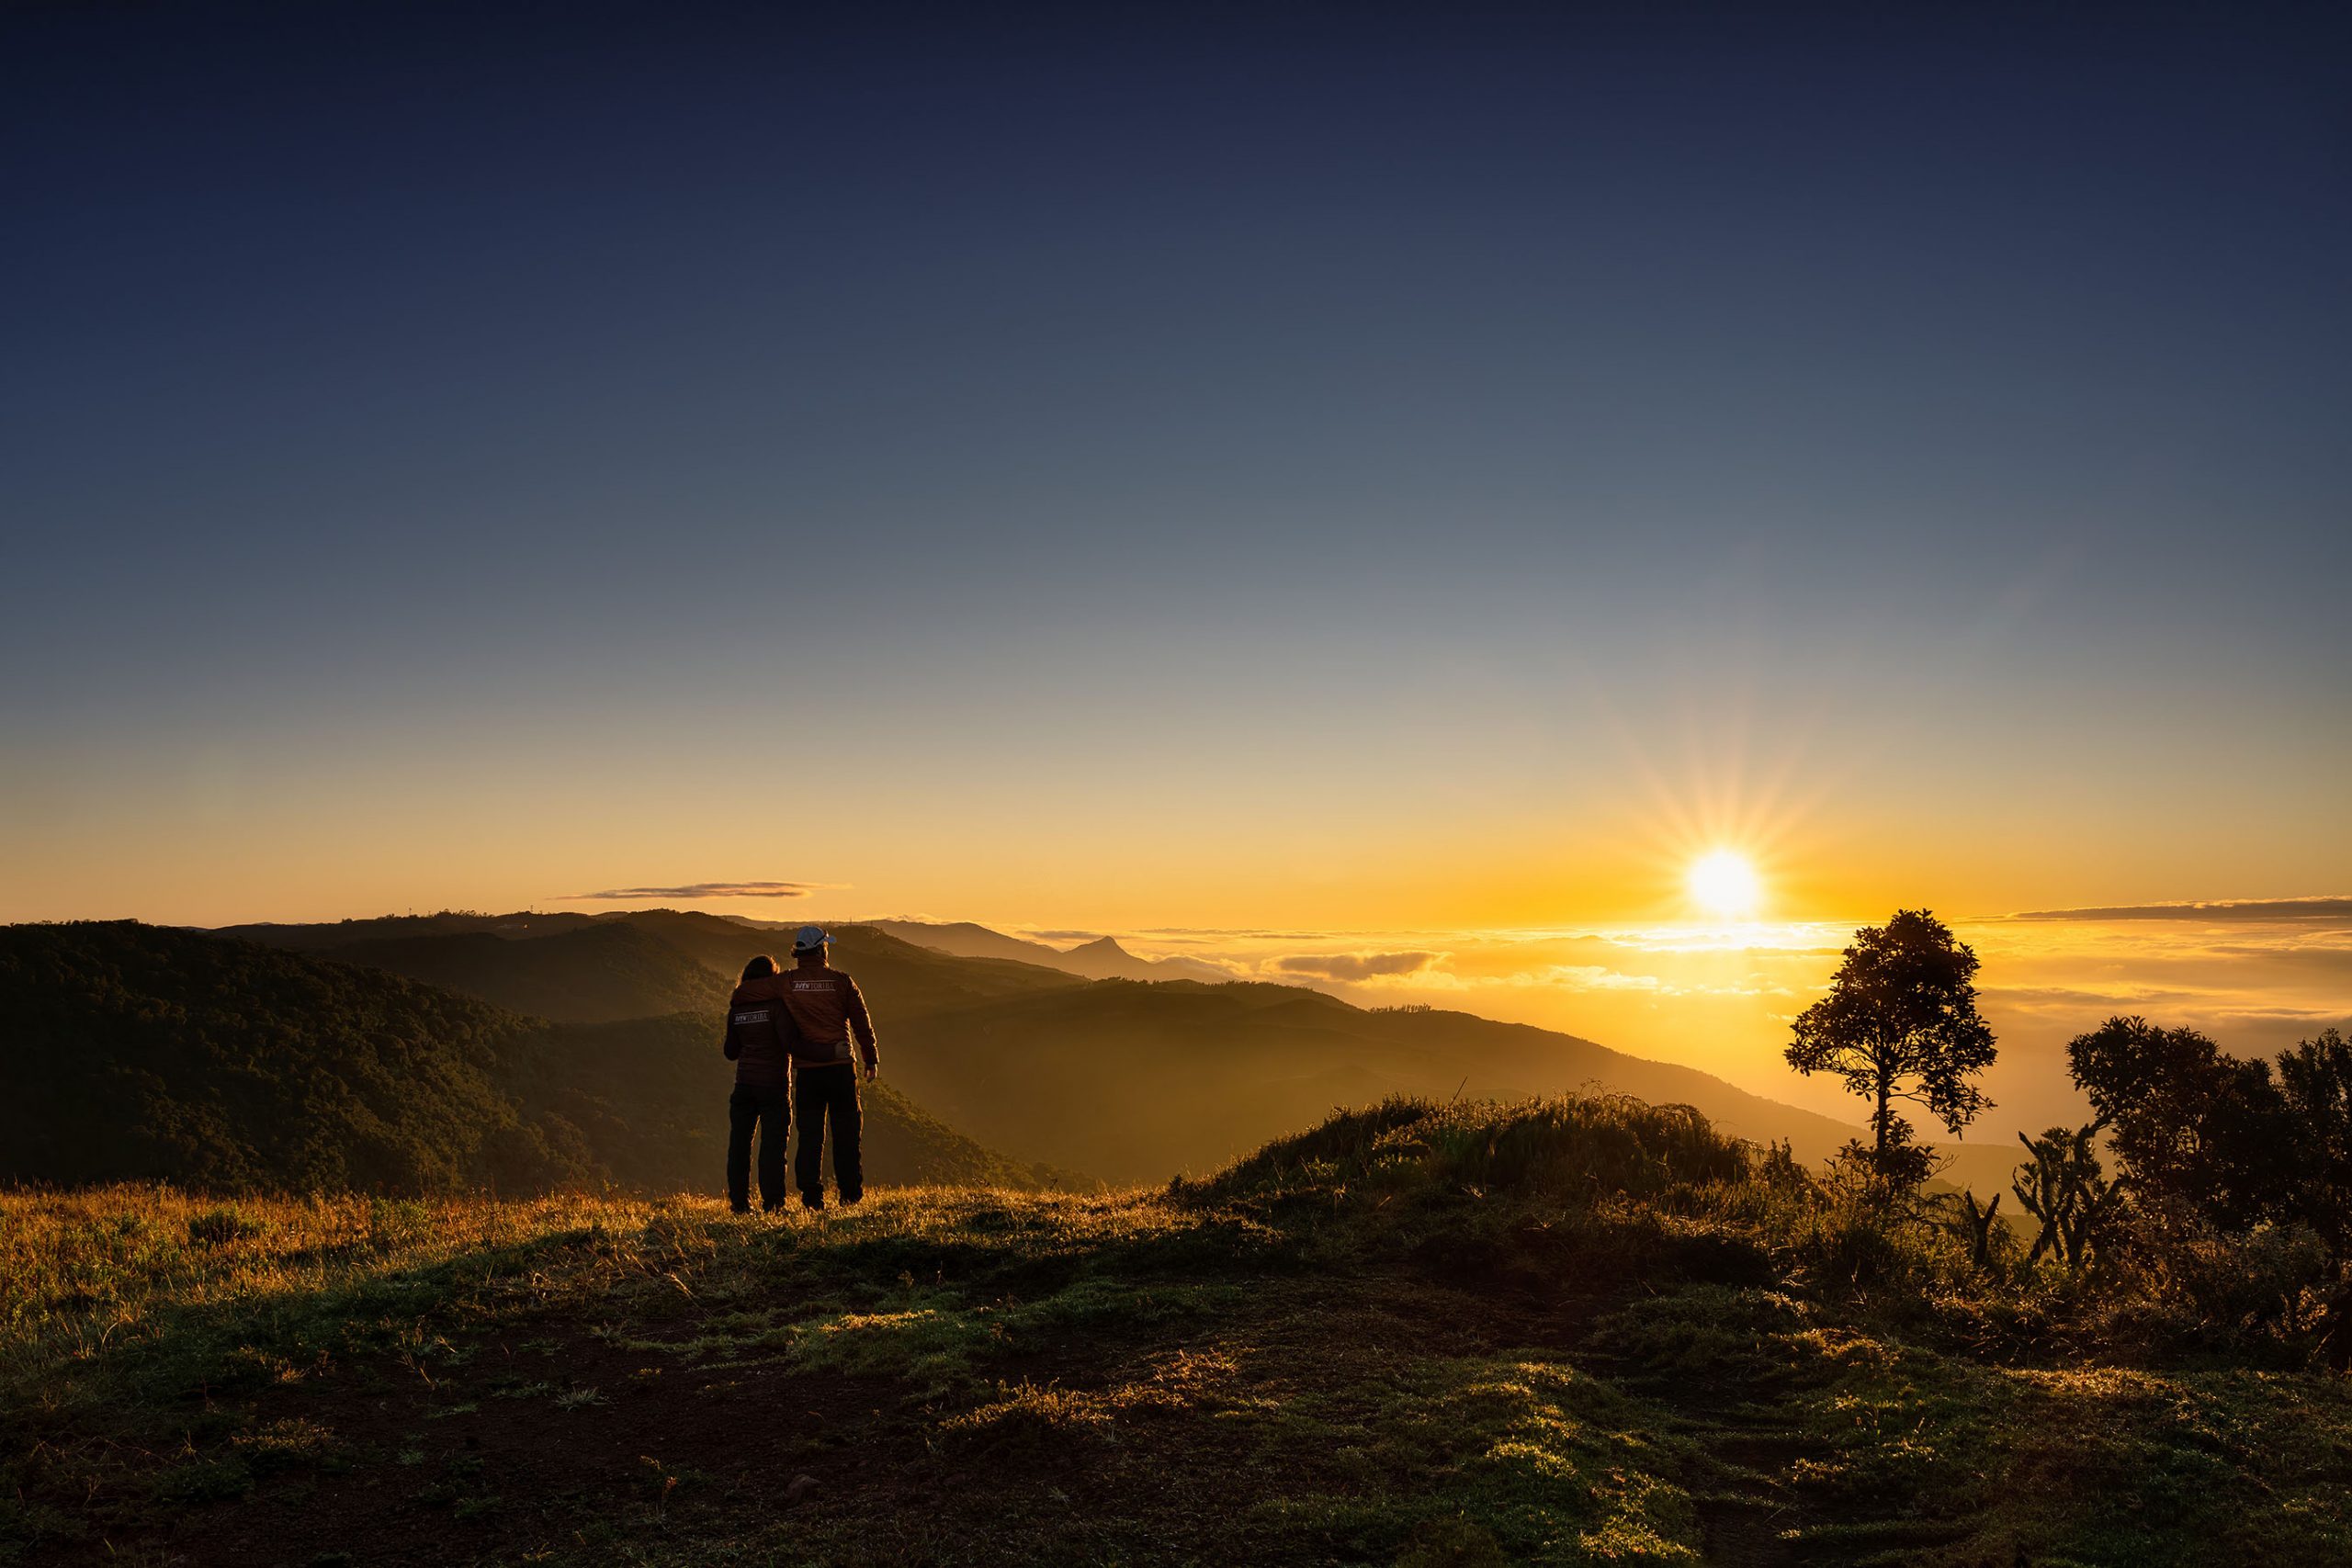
[{"xmin": 83, "ymin": 1324, "xmax": 922, "ymax": 1565}]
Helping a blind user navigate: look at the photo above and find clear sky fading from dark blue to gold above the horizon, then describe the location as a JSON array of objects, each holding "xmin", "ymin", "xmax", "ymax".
[{"xmin": 0, "ymin": 5, "xmax": 2352, "ymax": 1086}]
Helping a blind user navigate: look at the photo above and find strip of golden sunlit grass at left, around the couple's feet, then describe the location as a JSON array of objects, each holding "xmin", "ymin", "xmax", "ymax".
[{"xmin": 0, "ymin": 1187, "xmax": 1197, "ymax": 1411}]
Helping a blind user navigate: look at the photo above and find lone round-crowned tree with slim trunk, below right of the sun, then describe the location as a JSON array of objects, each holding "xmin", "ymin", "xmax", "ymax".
[{"xmin": 1788, "ymin": 909, "xmax": 1995, "ymax": 1180}]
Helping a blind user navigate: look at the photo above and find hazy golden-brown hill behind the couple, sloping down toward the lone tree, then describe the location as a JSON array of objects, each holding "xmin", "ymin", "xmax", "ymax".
[{"xmin": 192, "ymin": 909, "xmax": 1882, "ymax": 1190}]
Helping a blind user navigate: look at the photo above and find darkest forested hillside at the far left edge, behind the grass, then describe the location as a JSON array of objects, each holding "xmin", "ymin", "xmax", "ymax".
[{"xmin": 0, "ymin": 921, "xmax": 588, "ymax": 1192}]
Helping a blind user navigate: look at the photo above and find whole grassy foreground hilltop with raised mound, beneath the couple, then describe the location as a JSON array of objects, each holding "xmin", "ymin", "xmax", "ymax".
[{"xmin": 0, "ymin": 1100, "xmax": 2352, "ymax": 1568}]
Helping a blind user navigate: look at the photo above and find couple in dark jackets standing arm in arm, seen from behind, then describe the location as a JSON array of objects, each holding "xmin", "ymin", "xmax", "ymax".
[{"xmin": 724, "ymin": 926, "xmax": 882, "ymax": 1213}]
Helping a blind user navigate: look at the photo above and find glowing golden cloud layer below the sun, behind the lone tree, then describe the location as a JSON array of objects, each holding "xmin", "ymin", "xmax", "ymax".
[{"xmin": 1105, "ymin": 900, "xmax": 2352, "ymax": 1140}]
